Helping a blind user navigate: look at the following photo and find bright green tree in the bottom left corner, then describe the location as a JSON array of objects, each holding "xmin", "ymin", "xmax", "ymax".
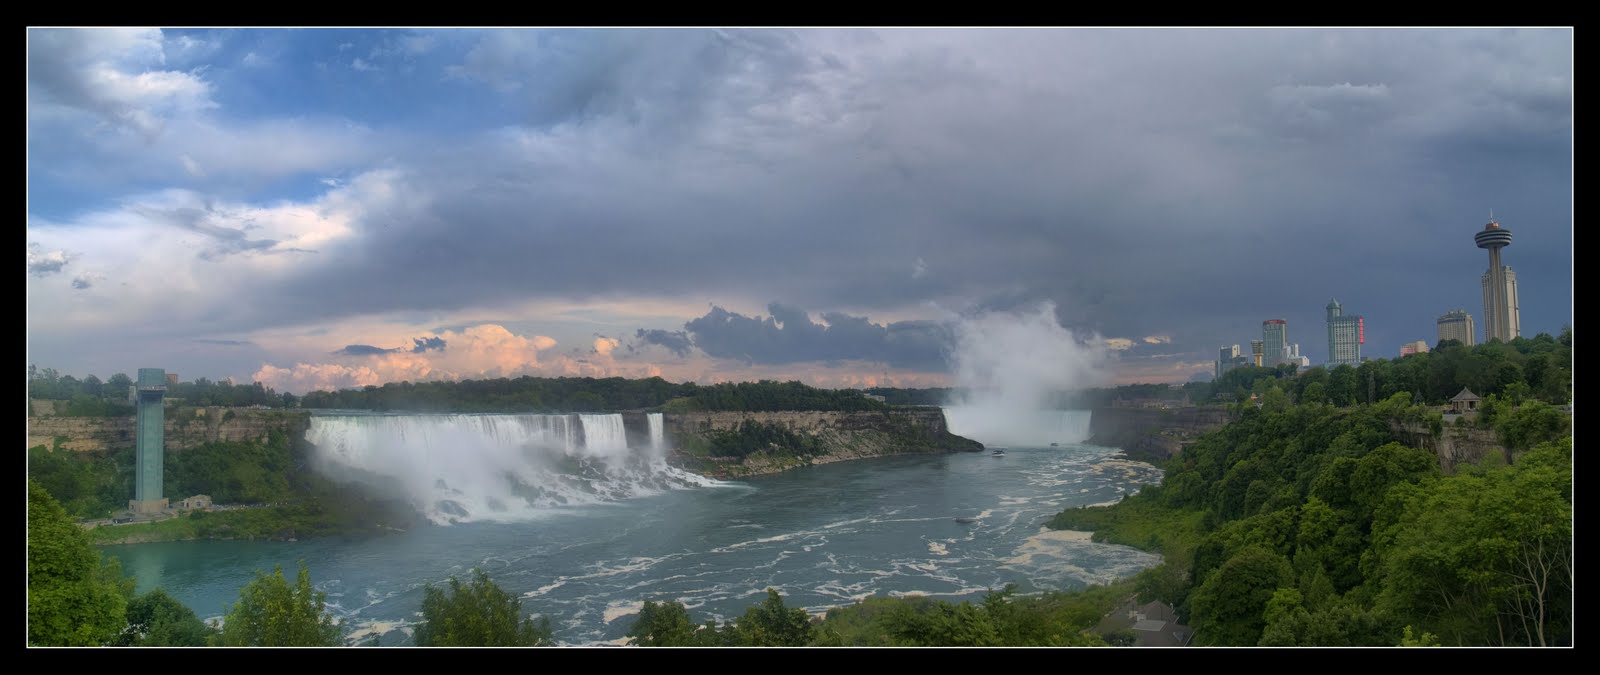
[{"xmin": 27, "ymin": 478, "xmax": 133, "ymax": 646}]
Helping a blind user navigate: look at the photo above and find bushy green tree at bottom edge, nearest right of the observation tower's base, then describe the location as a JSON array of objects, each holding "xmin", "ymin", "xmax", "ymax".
[{"xmin": 214, "ymin": 560, "xmax": 344, "ymax": 646}]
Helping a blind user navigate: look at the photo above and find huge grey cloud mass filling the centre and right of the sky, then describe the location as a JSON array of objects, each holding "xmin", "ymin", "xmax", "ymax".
[{"xmin": 29, "ymin": 29, "xmax": 1573, "ymax": 379}]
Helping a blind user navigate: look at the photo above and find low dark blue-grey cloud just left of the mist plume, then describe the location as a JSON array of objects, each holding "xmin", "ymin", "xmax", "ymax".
[{"xmin": 683, "ymin": 302, "xmax": 954, "ymax": 369}]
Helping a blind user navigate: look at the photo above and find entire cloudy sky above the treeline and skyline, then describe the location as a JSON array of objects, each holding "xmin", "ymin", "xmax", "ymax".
[{"xmin": 27, "ymin": 27, "xmax": 1573, "ymax": 393}]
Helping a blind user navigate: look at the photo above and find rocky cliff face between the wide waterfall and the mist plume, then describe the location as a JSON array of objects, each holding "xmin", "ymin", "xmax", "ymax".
[{"xmin": 662, "ymin": 408, "xmax": 984, "ymax": 478}]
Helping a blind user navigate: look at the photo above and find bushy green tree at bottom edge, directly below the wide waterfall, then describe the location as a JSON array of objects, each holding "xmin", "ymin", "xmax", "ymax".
[{"xmin": 416, "ymin": 569, "xmax": 554, "ymax": 646}]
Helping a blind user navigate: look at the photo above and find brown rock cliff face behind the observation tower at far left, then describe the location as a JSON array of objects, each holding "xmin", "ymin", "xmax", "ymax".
[{"xmin": 27, "ymin": 408, "xmax": 310, "ymax": 453}]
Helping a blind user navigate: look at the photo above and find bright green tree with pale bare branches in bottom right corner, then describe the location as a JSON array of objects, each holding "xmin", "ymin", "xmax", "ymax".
[{"xmin": 1363, "ymin": 440, "xmax": 1573, "ymax": 646}]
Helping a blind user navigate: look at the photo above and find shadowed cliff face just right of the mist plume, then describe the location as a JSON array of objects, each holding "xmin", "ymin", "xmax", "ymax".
[{"xmin": 1088, "ymin": 406, "xmax": 1229, "ymax": 464}]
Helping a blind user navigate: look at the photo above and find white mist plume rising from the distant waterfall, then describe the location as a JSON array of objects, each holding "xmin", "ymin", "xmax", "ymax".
[{"xmin": 944, "ymin": 302, "xmax": 1109, "ymax": 448}]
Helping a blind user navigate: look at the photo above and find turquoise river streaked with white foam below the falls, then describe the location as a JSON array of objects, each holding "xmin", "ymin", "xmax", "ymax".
[{"xmin": 104, "ymin": 445, "xmax": 1160, "ymax": 645}]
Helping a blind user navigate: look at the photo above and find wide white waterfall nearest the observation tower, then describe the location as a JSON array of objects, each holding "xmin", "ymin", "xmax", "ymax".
[{"xmin": 306, "ymin": 414, "xmax": 717, "ymax": 525}]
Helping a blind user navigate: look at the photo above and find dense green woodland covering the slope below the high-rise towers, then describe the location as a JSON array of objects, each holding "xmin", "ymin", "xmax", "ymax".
[{"xmin": 1050, "ymin": 385, "xmax": 1571, "ymax": 646}]
